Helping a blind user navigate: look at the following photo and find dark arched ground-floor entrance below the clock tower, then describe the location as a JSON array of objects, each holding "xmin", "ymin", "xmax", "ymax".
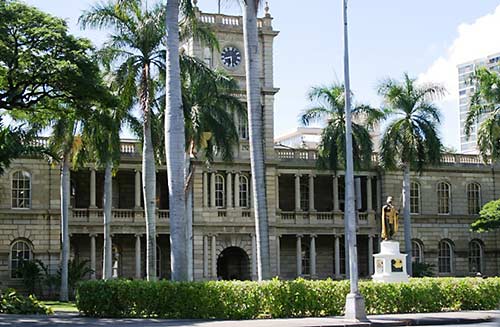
[{"xmin": 217, "ymin": 246, "xmax": 250, "ymax": 280}]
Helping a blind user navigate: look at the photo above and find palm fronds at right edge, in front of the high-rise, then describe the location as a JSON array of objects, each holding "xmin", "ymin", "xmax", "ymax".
[{"xmin": 464, "ymin": 68, "xmax": 500, "ymax": 164}]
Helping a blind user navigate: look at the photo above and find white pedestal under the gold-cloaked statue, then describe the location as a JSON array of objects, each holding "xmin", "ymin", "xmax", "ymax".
[{"xmin": 372, "ymin": 241, "xmax": 408, "ymax": 283}]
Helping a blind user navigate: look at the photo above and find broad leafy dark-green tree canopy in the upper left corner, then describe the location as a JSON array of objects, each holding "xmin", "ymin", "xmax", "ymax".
[{"xmin": 0, "ymin": 0, "xmax": 102, "ymax": 110}]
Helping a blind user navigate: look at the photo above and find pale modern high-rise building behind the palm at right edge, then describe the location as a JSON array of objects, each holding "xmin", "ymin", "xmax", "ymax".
[{"xmin": 458, "ymin": 53, "xmax": 500, "ymax": 153}]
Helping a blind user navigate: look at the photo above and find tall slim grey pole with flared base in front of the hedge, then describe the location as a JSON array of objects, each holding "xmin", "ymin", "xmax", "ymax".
[{"xmin": 343, "ymin": 0, "xmax": 367, "ymax": 320}]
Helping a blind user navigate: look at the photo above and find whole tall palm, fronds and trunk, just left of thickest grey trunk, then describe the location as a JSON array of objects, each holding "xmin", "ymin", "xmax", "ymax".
[{"xmin": 79, "ymin": 0, "xmax": 174, "ymax": 280}]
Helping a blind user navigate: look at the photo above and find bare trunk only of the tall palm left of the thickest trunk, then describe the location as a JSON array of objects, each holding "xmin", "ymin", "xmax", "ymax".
[{"xmin": 141, "ymin": 64, "xmax": 157, "ymax": 280}]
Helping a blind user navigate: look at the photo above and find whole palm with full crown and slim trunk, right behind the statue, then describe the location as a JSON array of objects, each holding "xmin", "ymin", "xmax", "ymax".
[{"xmin": 378, "ymin": 74, "xmax": 445, "ymax": 276}]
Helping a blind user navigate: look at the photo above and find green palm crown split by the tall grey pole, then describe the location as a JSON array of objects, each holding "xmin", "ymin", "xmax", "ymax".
[{"xmin": 300, "ymin": 84, "xmax": 383, "ymax": 171}]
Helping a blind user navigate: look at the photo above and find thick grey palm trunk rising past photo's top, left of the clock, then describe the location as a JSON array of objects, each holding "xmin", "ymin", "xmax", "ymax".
[{"xmin": 165, "ymin": 0, "xmax": 189, "ymax": 281}]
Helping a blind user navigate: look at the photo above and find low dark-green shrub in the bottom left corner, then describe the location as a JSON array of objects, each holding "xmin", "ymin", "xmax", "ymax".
[{"xmin": 0, "ymin": 289, "xmax": 53, "ymax": 315}]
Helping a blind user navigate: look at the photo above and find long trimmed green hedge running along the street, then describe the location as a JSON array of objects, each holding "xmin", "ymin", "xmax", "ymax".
[{"xmin": 76, "ymin": 278, "xmax": 500, "ymax": 319}]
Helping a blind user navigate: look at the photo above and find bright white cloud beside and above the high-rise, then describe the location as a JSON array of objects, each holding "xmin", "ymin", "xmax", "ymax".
[{"xmin": 419, "ymin": 6, "xmax": 500, "ymax": 149}]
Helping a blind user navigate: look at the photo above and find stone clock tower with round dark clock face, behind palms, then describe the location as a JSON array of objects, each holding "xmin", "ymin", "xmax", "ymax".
[{"xmin": 181, "ymin": 2, "xmax": 279, "ymax": 161}]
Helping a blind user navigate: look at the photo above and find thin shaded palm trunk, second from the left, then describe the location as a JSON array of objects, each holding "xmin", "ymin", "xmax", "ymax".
[{"xmin": 102, "ymin": 160, "xmax": 113, "ymax": 279}]
